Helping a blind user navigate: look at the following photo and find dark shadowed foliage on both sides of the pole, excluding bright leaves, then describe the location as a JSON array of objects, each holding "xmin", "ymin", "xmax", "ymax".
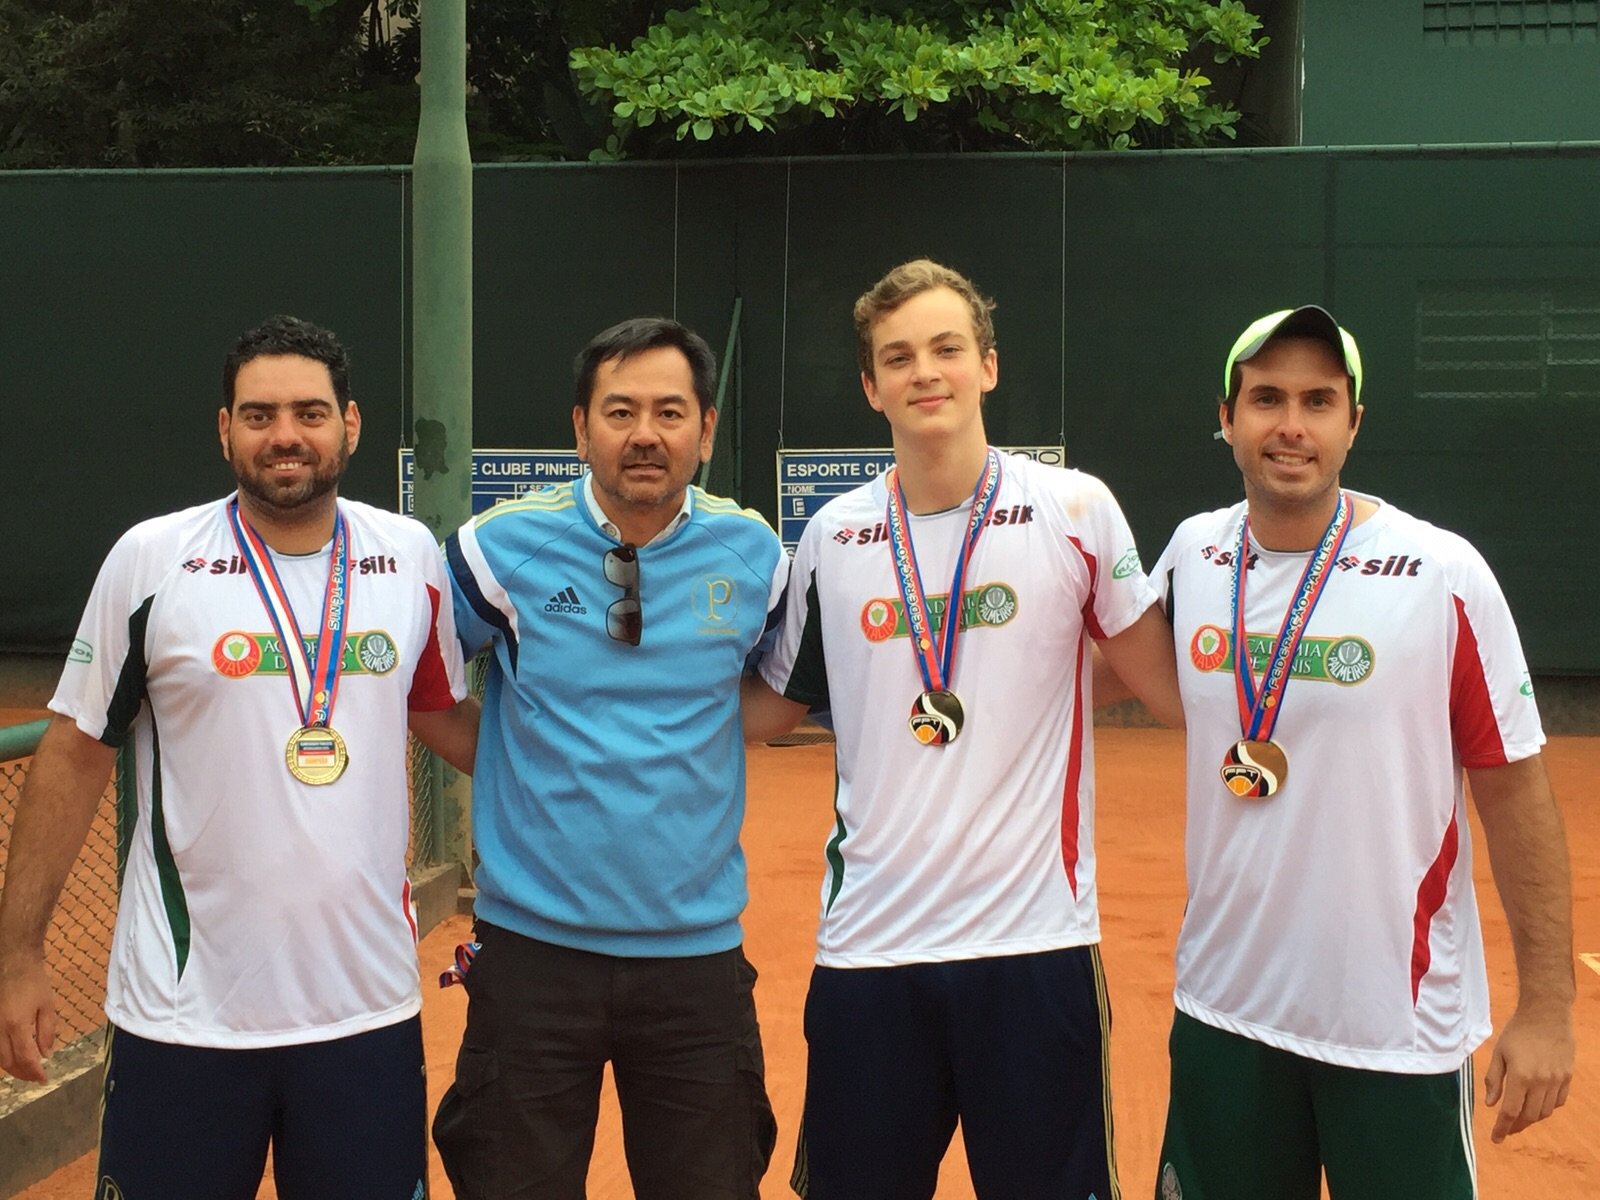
[{"xmin": 0, "ymin": 0, "xmax": 688, "ymax": 168}]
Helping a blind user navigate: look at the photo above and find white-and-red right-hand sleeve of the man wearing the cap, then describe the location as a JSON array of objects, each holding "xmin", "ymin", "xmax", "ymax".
[{"xmin": 1446, "ymin": 541, "xmax": 1544, "ymax": 766}]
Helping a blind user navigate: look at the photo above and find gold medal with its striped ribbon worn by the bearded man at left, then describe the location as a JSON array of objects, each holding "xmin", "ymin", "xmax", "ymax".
[{"xmin": 227, "ymin": 496, "xmax": 350, "ymax": 784}]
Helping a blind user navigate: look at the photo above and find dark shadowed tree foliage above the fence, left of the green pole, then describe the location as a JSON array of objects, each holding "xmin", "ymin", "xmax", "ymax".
[{"xmin": 0, "ymin": 0, "xmax": 416, "ymax": 168}]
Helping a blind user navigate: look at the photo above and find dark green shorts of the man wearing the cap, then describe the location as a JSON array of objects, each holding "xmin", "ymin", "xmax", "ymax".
[{"xmin": 1155, "ymin": 1013, "xmax": 1478, "ymax": 1200}]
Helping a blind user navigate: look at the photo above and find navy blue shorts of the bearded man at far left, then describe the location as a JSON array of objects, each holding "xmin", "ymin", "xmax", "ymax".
[{"xmin": 94, "ymin": 1018, "xmax": 427, "ymax": 1200}]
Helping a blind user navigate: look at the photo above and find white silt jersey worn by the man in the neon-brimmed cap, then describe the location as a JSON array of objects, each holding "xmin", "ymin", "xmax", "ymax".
[{"xmin": 1154, "ymin": 498, "xmax": 1544, "ymax": 1074}]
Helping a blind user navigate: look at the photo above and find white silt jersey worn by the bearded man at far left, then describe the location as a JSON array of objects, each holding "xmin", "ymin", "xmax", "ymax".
[{"xmin": 50, "ymin": 501, "xmax": 466, "ymax": 1048}]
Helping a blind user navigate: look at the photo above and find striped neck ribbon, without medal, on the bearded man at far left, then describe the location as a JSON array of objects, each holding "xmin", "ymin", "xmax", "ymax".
[{"xmin": 227, "ymin": 496, "xmax": 350, "ymax": 728}]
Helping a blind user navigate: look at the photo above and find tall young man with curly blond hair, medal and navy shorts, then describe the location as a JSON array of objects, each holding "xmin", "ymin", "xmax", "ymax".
[{"xmin": 746, "ymin": 259, "xmax": 1179, "ymax": 1200}]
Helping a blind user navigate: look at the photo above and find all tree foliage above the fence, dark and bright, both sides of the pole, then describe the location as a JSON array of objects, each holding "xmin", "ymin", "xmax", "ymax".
[{"xmin": 0, "ymin": 0, "xmax": 1262, "ymax": 168}]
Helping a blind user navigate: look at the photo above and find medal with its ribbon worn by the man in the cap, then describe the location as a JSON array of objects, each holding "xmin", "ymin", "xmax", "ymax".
[{"xmin": 1221, "ymin": 491, "xmax": 1355, "ymax": 798}]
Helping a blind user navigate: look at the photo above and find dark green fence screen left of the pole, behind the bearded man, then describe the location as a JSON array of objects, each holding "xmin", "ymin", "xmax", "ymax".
[{"xmin": 0, "ymin": 171, "xmax": 406, "ymax": 650}]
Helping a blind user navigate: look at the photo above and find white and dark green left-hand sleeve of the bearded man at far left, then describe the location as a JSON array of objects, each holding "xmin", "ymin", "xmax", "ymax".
[{"xmin": 50, "ymin": 528, "xmax": 155, "ymax": 746}]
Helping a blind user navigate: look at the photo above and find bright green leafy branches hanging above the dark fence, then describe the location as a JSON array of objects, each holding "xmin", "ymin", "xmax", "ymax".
[{"xmin": 571, "ymin": 0, "xmax": 1266, "ymax": 157}]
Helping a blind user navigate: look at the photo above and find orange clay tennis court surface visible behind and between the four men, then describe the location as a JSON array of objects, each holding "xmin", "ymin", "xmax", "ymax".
[{"xmin": 12, "ymin": 728, "xmax": 1600, "ymax": 1200}]
